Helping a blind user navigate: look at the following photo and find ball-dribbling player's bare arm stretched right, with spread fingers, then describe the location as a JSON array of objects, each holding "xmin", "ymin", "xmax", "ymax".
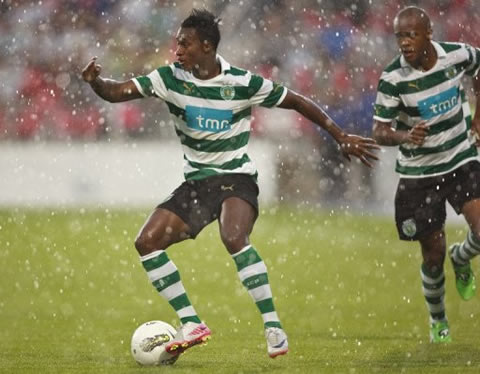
[{"xmin": 278, "ymin": 90, "xmax": 379, "ymax": 167}]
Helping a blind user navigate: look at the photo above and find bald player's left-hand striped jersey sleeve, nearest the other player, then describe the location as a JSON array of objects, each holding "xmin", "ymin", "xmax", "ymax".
[{"xmin": 373, "ymin": 73, "xmax": 400, "ymax": 122}]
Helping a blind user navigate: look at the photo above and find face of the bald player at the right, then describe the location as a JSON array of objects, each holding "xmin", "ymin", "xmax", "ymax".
[{"xmin": 393, "ymin": 16, "xmax": 432, "ymax": 66}]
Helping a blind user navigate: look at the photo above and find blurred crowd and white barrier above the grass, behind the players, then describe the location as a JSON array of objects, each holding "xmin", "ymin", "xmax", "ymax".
[{"xmin": 0, "ymin": 0, "xmax": 480, "ymax": 214}]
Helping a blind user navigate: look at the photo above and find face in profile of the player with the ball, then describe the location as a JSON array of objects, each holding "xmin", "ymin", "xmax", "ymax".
[{"xmin": 175, "ymin": 28, "xmax": 205, "ymax": 71}]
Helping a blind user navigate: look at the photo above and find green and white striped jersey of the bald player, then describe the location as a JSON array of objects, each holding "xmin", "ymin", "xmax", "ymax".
[{"xmin": 374, "ymin": 42, "xmax": 480, "ymax": 178}]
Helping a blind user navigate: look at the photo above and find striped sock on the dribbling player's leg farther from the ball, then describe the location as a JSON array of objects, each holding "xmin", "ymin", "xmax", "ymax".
[{"xmin": 232, "ymin": 245, "xmax": 282, "ymax": 328}]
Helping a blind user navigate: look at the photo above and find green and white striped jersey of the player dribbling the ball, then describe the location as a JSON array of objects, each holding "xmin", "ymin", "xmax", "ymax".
[{"xmin": 133, "ymin": 56, "xmax": 287, "ymax": 180}]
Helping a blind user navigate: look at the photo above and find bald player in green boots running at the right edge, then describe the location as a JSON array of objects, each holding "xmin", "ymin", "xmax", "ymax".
[{"xmin": 373, "ymin": 7, "xmax": 480, "ymax": 343}]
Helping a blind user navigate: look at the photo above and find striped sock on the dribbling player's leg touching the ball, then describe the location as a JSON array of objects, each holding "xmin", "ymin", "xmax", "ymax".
[{"xmin": 140, "ymin": 251, "xmax": 201, "ymax": 324}]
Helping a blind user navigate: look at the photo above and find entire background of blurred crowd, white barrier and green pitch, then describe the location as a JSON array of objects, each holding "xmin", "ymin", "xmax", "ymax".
[{"xmin": 0, "ymin": 0, "xmax": 480, "ymax": 374}]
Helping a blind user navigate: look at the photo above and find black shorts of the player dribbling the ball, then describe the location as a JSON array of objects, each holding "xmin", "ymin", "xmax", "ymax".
[{"xmin": 158, "ymin": 174, "xmax": 258, "ymax": 238}]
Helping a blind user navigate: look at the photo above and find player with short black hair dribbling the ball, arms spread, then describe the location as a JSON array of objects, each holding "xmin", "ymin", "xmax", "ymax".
[{"xmin": 82, "ymin": 9, "xmax": 379, "ymax": 358}]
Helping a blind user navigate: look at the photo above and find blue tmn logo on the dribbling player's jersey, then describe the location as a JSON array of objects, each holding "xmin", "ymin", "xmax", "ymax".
[{"xmin": 185, "ymin": 105, "xmax": 233, "ymax": 132}]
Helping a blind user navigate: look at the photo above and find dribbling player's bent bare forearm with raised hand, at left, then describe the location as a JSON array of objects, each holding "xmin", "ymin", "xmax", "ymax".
[{"xmin": 82, "ymin": 57, "xmax": 143, "ymax": 103}]
